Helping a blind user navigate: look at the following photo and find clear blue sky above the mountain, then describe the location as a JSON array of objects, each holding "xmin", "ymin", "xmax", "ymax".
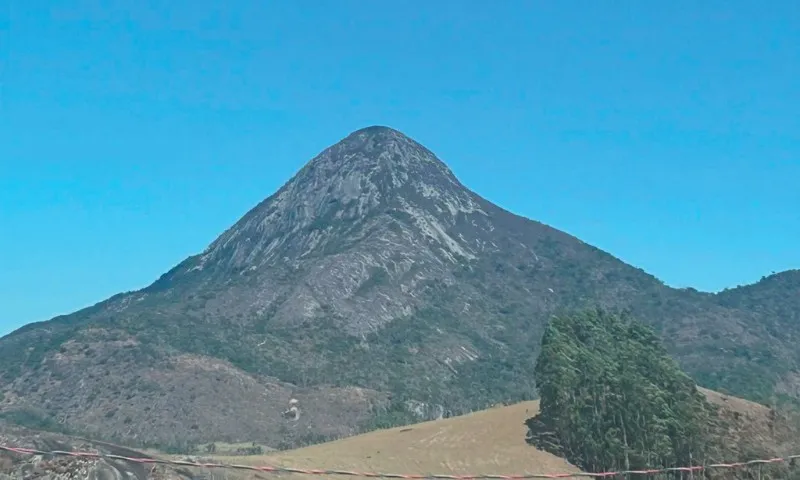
[{"xmin": 0, "ymin": 0, "xmax": 800, "ymax": 333}]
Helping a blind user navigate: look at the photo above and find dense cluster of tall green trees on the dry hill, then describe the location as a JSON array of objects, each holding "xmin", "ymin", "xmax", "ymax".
[{"xmin": 528, "ymin": 310, "xmax": 715, "ymax": 471}]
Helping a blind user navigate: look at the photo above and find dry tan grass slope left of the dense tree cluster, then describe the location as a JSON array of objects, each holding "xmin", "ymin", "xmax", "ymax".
[{"xmin": 214, "ymin": 401, "xmax": 579, "ymax": 478}]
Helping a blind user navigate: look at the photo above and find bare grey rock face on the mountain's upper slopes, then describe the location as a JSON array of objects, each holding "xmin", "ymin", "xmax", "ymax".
[{"xmin": 154, "ymin": 127, "xmax": 498, "ymax": 335}]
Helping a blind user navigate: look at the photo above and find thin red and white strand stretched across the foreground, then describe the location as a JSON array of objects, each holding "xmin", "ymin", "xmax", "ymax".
[{"xmin": 0, "ymin": 445, "xmax": 800, "ymax": 480}]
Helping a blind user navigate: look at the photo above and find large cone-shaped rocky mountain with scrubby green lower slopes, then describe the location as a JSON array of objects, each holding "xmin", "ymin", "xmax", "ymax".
[{"xmin": 0, "ymin": 127, "xmax": 800, "ymax": 449}]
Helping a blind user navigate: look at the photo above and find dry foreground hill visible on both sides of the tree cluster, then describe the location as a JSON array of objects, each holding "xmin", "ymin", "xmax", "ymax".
[{"xmin": 209, "ymin": 389, "xmax": 798, "ymax": 475}]
